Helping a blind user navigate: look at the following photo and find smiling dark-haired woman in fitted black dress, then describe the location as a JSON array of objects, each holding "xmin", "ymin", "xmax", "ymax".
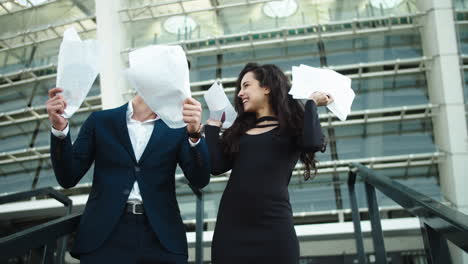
[{"xmin": 205, "ymin": 63, "xmax": 332, "ymax": 264}]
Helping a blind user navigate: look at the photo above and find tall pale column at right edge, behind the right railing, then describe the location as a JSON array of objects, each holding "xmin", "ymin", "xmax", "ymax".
[{"xmin": 417, "ymin": 0, "xmax": 468, "ymax": 264}]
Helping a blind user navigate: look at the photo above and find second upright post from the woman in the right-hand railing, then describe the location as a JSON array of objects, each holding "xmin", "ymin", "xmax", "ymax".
[{"xmin": 365, "ymin": 182, "xmax": 387, "ymax": 263}]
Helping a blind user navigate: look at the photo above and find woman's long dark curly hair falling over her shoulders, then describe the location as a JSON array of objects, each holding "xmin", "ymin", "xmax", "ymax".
[{"xmin": 221, "ymin": 63, "xmax": 317, "ymax": 180}]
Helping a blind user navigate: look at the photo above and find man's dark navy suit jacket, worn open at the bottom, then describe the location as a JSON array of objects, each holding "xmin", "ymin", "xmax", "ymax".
[{"xmin": 51, "ymin": 104, "xmax": 210, "ymax": 257}]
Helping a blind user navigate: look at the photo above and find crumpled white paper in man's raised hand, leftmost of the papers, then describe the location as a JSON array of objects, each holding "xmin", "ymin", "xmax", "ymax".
[{"xmin": 56, "ymin": 27, "xmax": 99, "ymax": 118}]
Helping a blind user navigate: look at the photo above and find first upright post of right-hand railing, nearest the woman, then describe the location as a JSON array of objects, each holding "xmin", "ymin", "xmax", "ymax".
[{"xmin": 348, "ymin": 170, "xmax": 367, "ymax": 264}]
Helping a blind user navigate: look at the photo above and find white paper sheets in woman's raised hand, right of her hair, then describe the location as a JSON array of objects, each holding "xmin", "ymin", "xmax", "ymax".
[{"xmin": 289, "ymin": 64, "xmax": 355, "ymax": 121}]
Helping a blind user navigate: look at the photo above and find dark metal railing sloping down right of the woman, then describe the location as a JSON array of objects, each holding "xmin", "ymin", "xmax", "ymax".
[{"xmin": 348, "ymin": 163, "xmax": 468, "ymax": 264}]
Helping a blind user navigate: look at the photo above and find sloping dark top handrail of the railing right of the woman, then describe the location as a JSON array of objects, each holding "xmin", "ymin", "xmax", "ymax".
[{"xmin": 350, "ymin": 163, "xmax": 468, "ymax": 252}]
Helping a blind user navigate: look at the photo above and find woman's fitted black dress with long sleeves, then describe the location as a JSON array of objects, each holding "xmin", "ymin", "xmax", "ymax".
[{"xmin": 205, "ymin": 101, "xmax": 324, "ymax": 264}]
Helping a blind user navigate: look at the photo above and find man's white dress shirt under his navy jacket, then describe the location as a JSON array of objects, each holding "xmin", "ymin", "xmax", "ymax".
[{"xmin": 52, "ymin": 101, "xmax": 200, "ymax": 203}]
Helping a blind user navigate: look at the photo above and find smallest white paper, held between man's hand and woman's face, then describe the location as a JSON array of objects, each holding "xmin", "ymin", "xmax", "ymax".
[{"xmin": 204, "ymin": 82, "xmax": 237, "ymax": 129}]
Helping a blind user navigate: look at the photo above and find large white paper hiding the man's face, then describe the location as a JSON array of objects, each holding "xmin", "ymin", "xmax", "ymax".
[{"xmin": 125, "ymin": 45, "xmax": 191, "ymax": 128}]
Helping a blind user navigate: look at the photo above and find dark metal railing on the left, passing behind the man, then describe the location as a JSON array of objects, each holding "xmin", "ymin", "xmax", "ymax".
[{"xmin": 0, "ymin": 185, "xmax": 204, "ymax": 264}]
